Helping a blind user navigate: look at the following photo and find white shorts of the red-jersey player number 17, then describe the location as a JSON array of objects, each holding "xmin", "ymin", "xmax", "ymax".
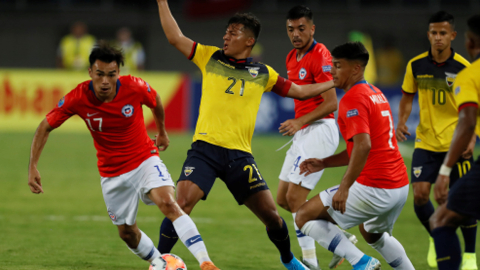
[{"xmin": 101, "ymin": 156, "xmax": 175, "ymax": 225}]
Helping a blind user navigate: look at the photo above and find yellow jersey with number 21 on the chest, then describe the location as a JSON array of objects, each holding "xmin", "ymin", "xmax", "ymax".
[{"xmin": 189, "ymin": 43, "xmax": 279, "ymax": 153}]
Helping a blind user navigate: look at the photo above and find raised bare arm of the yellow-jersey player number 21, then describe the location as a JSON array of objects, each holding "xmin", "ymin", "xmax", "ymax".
[{"xmin": 157, "ymin": 0, "xmax": 193, "ymax": 57}]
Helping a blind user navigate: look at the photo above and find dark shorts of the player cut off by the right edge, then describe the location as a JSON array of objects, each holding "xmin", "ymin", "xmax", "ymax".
[{"xmin": 447, "ymin": 157, "xmax": 480, "ymax": 219}]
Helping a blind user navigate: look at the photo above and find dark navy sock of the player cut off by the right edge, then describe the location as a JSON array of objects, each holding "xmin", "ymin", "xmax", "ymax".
[{"xmin": 432, "ymin": 227, "xmax": 462, "ymax": 270}]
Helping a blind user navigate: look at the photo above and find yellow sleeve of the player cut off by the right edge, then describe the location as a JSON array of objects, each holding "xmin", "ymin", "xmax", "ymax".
[{"xmin": 453, "ymin": 68, "xmax": 480, "ymax": 111}]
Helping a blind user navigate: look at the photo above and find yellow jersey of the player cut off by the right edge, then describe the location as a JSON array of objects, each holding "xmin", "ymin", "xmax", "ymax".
[{"xmin": 454, "ymin": 57, "xmax": 480, "ymax": 136}]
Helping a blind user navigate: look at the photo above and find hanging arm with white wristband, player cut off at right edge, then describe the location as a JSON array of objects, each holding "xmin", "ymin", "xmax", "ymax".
[{"xmin": 434, "ymin": 106, "xmax": 478, "ymax": 204}]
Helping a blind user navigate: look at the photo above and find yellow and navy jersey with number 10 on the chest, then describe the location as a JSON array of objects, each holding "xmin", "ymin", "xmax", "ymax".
[{"xmin": 402, "ymin": 50, "xmax": 470, "ymax": 152}]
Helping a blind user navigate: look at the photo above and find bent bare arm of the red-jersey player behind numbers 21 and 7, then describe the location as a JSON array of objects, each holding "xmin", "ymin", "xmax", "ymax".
[{"xmin": 279, "ymin": 88, "xmax": 337, "ymax": 136}]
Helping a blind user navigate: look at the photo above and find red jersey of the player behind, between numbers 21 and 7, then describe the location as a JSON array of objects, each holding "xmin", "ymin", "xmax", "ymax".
[{"xmin": 287, "ymin": 40, "xmax": 335, "ymax": 123}]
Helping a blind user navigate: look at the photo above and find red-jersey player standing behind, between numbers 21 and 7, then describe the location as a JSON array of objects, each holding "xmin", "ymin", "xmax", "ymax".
[{"xmin": 277, "ymin": 5, "xmax": 356, "ymax": 270}]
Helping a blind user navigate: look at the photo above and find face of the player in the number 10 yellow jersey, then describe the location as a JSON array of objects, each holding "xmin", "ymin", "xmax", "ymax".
[{"xmin": 428, "ymin": 22, "xmax": 457, "ymax": 52}]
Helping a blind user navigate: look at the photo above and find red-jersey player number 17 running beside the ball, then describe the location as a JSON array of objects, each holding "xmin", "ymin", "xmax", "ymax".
[{"xmin": 28, "ymin": 43, "xmax": 218, "ymax": 270}]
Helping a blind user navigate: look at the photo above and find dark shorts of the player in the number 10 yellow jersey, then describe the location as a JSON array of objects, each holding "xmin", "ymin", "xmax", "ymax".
[{"xmin": 411, "ymin": 148, "xmax": 474, "ymax": 186}]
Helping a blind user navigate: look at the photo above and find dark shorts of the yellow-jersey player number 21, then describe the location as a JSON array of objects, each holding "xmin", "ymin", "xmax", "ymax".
[{"xmin": 178, "ymin": 141, "xmax": 268, "ymax": 205}]
